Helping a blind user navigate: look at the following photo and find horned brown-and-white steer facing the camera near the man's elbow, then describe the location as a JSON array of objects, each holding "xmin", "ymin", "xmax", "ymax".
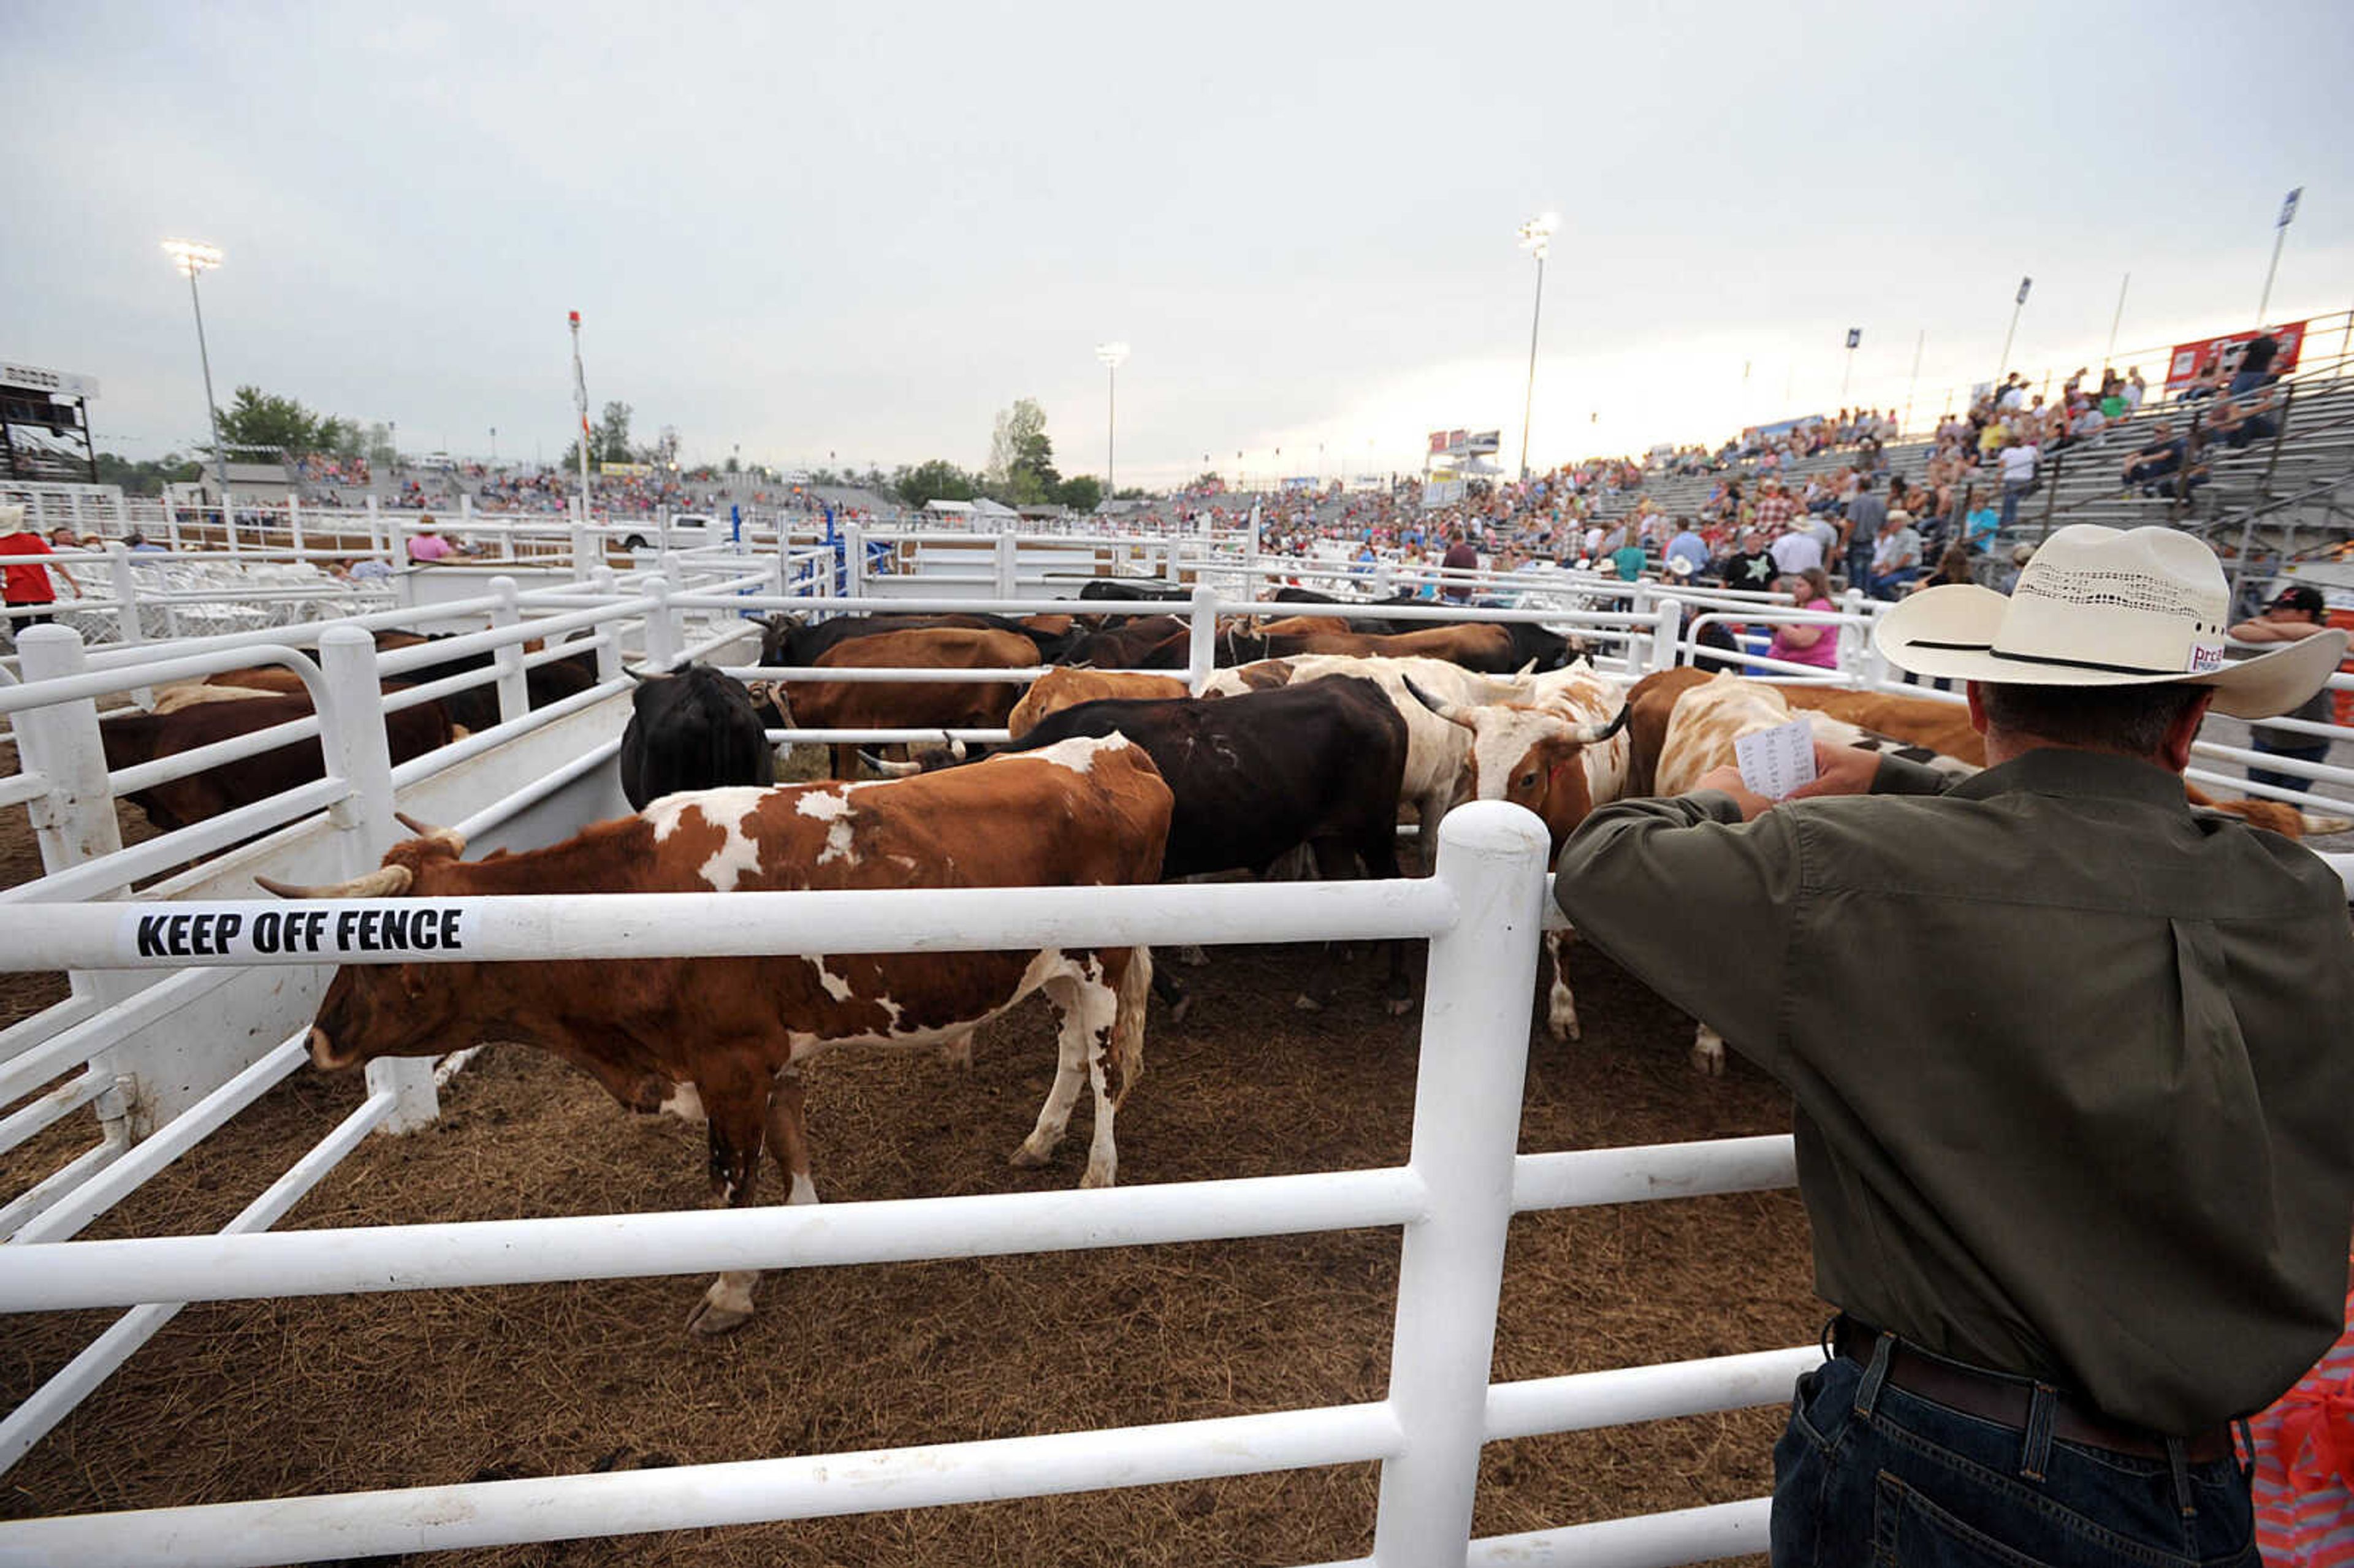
[{"xmin": 1417, "ymin": 661, "xmax": 1629, "ymax": 1041}]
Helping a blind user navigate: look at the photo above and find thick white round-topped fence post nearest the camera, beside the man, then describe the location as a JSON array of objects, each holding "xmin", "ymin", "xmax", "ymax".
[{"xmin": 1373, "ymin": 801, "xmax": 1547, "ymax": 1568}]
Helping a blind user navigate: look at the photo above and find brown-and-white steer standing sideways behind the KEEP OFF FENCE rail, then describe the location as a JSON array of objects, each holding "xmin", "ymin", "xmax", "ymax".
[{"xmin": 264, "ymin": 734, "xmax": 1172, "ymax": 1335}]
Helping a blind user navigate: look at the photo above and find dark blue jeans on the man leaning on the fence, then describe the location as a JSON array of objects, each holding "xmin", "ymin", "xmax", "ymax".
[{"xmin": 1770, "ymin": 1356, "xmax": 2258, "ymax": 1568}]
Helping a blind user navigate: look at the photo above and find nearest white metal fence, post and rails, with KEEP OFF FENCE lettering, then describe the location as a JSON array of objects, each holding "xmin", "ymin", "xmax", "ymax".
[{"xmin": 0, "ymin": 803, "xmax": 1808, "ymax": 1568}]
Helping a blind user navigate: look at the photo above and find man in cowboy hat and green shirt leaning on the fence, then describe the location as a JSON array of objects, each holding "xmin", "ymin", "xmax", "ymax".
[{"xmin": 1553, "ymin": 525, "xmax": 2354, "ymax": 1568}]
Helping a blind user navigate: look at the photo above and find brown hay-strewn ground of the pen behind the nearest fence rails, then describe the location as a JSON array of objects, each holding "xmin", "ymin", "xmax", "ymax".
[{"xmin": 0, "ymin": 932, "xmax": 1822, "ymax": 1568}]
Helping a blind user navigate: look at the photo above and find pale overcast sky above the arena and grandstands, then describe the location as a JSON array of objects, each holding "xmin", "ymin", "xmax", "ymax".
[{"xmin": 0, "ymin": 0, "xmax": 2354, "ymax": 482}]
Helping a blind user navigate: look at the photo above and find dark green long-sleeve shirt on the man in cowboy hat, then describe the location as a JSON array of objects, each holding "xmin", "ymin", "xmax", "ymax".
[{"xmin": 1553, "ymin": 748, "xmax": 2354, "ymax": 1434}]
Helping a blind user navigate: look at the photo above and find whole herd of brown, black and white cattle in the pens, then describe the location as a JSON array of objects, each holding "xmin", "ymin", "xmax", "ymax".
[{"xmin": 124, "ymin": 588, "xmax": 2340, "ymax": 1333}]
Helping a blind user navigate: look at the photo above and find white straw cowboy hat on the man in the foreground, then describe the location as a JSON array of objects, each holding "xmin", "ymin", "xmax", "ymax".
[{"xmin": 1872, "ymin": 523, "xmax": 2347, "ymax": 718}]
